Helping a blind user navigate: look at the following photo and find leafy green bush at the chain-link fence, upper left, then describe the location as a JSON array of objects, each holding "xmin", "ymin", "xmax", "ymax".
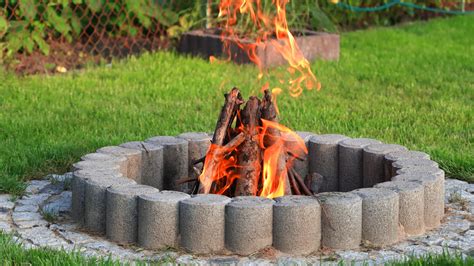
[{"xmin": 0, "ymin": 0, "xmax": 184, "ymax": 58}]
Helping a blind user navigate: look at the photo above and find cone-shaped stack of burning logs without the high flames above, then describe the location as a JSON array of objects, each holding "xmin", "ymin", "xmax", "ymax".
[{"xmin": 195, "ymin": 88, "xmax": 312, "ymax": 197}]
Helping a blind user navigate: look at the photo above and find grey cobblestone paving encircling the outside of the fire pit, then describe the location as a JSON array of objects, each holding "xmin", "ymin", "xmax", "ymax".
[{"xmin": 0, "ymin": 174, "xmax": 474, "ymax": 265}]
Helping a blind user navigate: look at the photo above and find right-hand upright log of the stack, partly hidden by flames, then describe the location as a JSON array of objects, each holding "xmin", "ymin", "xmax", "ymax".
[{"xmin": 261, "ymin": 90, "xmax": 291, "ymax": 195}]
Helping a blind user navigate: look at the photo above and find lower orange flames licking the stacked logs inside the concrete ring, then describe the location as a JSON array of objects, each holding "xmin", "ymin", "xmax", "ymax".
[{"xmin": 199, "ymin": 116, "xmax": 308, "ymax": 198}]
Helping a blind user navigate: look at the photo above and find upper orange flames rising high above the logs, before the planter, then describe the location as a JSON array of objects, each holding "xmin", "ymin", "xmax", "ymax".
[{"xmin": 216, "ymin": 0, "xmax": 321, "ymax": 97}]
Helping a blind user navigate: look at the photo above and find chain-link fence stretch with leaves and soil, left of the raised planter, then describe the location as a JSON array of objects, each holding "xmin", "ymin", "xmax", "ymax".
[{"xmin": 0, "ymin": 0, "xmax": 189, "ymax": 72}]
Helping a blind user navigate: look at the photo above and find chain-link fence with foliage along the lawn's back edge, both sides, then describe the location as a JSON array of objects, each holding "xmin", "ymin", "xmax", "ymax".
[{"xmin": 0, "ymin": 0, "xmax": 474, "ymax": 74}]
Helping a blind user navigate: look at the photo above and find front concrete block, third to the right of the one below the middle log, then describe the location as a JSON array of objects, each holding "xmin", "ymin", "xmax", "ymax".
[{"xmin": 352, "ymin": 188, "xmax": 399, "ymax": 246}]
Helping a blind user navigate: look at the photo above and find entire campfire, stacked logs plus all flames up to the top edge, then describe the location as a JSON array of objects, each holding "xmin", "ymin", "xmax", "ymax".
[{"xmin": 180, "ymin": 0, "xmax": 320, "ymax": 198}]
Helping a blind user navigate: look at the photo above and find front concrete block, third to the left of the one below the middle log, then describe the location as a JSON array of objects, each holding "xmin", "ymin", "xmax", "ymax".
[{"xmin": 105, "ymin": 185, "xmax": 158, "ymax": 244}]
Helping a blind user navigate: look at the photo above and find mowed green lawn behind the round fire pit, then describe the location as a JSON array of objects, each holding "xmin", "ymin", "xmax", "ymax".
[{"xmin": 0, "ymin": 16, "xmax": 474, "ymax": 192}]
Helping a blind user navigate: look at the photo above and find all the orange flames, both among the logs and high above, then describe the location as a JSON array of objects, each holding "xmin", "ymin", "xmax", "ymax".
[{"xmin": 199, "ymin": 0, "xmax": 321, "ymax": 198}]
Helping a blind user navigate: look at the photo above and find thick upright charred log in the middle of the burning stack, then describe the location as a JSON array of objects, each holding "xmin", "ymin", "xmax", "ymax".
[{"xmin": 234, "ymin": 96, "xmax": 262, "ymax": 196}]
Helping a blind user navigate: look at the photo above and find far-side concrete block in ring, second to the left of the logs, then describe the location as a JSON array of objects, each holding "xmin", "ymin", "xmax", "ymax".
[{"xmin": 146, "ymin": 136, "xmax": 189, "ymax": 191}]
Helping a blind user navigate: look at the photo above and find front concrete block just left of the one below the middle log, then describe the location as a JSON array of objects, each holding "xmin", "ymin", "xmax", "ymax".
[{"xmin": 179, "ymin": 194, "xmax": 231, "ymax": 254}]
